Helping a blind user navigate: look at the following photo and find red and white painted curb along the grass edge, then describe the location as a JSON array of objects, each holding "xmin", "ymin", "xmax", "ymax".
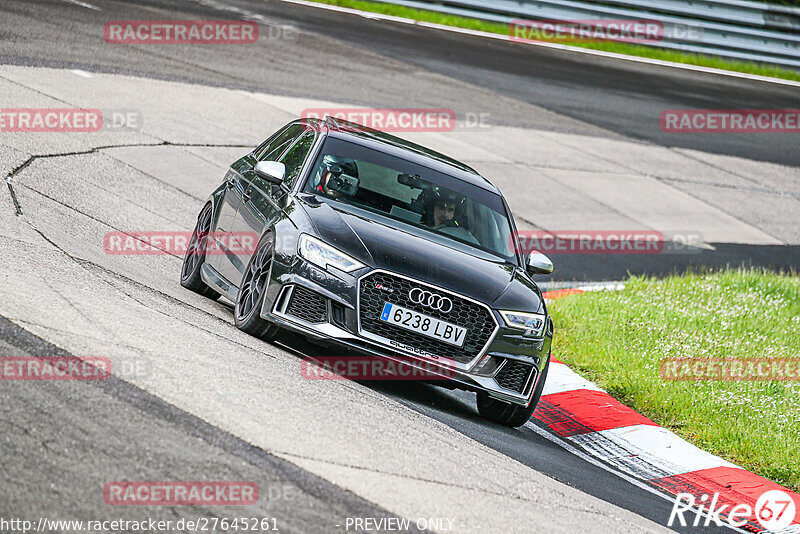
[{"xmin": 533, "ymin": 287, "xmax": 800, "ymax": 534}]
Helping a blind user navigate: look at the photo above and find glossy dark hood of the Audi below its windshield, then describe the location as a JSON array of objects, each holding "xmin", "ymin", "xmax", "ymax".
[{"xmin": 301, "ymin": 197, "xmax": 540, "ymax": 311}]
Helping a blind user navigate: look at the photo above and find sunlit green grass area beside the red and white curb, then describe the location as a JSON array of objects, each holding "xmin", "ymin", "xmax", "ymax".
[{"xmin": 549, "ymin": 270, "xmax": 800, "ymax": 491}]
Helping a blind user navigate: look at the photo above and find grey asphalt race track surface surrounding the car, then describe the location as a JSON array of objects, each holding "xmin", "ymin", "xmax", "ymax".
[{"xmin": 0, "ymin": 0, "xmax": 800, "ymax": 532}]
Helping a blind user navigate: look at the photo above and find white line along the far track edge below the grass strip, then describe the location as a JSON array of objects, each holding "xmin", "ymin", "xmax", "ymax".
[{"xmin": 280, "ymin": 0, "xmax": 800, "ymax": 87}]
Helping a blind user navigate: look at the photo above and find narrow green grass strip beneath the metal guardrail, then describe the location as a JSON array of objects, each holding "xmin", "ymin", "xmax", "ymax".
[{"xmin": 300, "ymin": 0, "xmax": 800, "ymax": 81}]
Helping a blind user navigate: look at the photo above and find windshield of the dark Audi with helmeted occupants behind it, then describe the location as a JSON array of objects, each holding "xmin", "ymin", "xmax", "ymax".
[{"xmin": 304, "ymin": 138, "xmax": 517, "ymax": 264}]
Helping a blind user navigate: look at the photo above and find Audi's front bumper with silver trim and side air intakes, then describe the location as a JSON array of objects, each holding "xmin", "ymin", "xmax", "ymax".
[{"xmin": 261, "ymin": 257, "xmax": 552, "ymax": 406}]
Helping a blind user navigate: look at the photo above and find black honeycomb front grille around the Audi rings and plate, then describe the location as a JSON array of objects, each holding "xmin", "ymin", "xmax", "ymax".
[{"xmin": 359, "ymin": 272, "xmax": 496, "ymax": 364}]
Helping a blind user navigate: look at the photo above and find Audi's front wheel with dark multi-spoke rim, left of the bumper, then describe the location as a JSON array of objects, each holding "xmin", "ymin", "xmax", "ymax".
[{"xmin": 233, "ymin": 234, "xmax": 280, "ymax": 341}]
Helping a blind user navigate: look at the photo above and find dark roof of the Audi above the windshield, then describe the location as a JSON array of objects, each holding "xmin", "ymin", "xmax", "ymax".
[{"xmin": 297, "ymin": 116, "xmax": 500, "ymax": 194}]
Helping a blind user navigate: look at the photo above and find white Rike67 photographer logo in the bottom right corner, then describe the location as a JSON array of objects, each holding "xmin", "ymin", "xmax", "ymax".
[{"xmin": 667, "ymin": 490, "xmax": 797, "ymax": 532}]
